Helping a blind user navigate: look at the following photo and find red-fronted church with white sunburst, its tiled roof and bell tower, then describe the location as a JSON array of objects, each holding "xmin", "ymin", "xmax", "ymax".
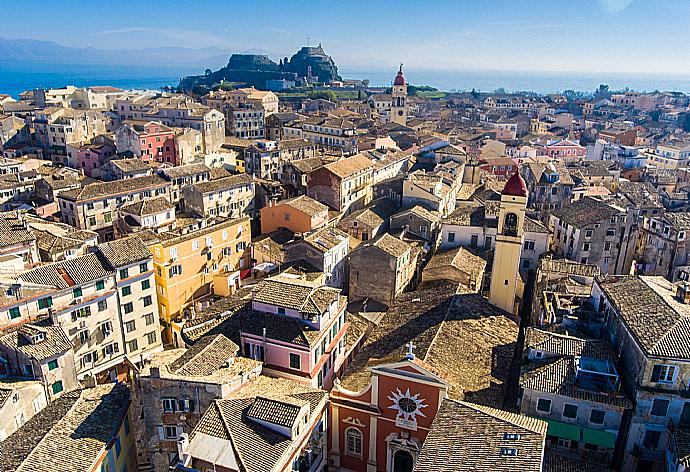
[{"xmin": 328, "ymin": 174, "xmax": 528, "ymax": 472}]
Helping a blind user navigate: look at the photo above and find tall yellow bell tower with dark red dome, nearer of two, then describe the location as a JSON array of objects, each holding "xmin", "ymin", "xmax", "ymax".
[{"xmin": 489, "ymin": 172, "xmax": 527, "ymax": 313}]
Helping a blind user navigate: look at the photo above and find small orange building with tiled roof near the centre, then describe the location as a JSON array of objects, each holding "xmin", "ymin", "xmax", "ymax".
[{"xmin": 261, "ymin": 195, "xmax": 328, "ymax": 234}]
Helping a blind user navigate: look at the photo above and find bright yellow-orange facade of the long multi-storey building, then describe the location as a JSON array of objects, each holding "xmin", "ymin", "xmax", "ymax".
[{"xmin": 151, "ymin": 217, "xmax": 251, "ymax": 342}]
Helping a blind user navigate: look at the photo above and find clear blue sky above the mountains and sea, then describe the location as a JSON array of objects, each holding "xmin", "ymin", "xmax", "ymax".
[{"xmin": 0, "ymin": 0, "xmax": 690, "ymax": 75}]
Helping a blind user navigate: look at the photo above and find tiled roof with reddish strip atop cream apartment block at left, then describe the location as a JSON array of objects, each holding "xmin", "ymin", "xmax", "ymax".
[{"xmin": 17, "ymin": 253, "xmax": 111, "ymax": 290}]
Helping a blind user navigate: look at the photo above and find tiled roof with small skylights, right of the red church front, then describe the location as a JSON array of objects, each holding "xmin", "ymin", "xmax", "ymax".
[{"xmin": 414, "ymin": 400, "xmax": 547, "ymax": 472}]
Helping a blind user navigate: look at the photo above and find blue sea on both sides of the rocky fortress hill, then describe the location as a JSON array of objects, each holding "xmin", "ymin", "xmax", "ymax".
[{"xmin": 0, "ymin": 59, "xmax": 690, "ymax": 97}]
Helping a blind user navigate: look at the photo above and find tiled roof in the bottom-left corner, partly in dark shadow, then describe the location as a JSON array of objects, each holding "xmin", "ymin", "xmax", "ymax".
[{"xmin": 3, "ymin": 384, "xmax": 130, "ymax": 472}]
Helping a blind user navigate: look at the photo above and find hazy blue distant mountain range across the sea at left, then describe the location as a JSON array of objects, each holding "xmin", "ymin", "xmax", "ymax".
[{"xmin": 0, "ymin": 38, "xmax": 231, "ymax": 66}]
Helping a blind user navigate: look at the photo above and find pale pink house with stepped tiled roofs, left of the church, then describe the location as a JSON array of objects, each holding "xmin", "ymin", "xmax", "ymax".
[{"xmin": 240, "ymin": 276, "xmax": 349, "ymax": 389}]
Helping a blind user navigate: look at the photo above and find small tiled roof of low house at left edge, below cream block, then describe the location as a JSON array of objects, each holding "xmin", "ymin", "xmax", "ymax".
[{"xmin": 0, "ymin": 320, "xmax": 72, "ymax": 362}]
